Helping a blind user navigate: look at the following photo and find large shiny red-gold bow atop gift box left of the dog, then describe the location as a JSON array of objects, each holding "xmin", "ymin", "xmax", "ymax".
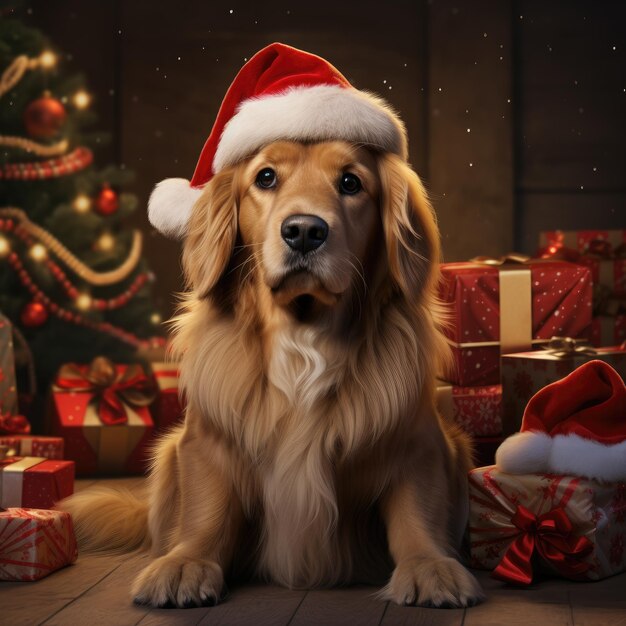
[{"xmin": 56, "ymin": 356, "xmax": 155, "ymax": 426}]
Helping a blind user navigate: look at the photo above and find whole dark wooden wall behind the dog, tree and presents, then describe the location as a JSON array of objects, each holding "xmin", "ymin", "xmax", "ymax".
[{"xmin": 30, "ymin": 0, "xmax": 626, "ymax": 310}]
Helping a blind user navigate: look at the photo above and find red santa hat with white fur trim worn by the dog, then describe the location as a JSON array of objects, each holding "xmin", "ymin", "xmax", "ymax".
[{"xmin": 148, "ymin": 43, "xmax": 407, "ymax": 236}]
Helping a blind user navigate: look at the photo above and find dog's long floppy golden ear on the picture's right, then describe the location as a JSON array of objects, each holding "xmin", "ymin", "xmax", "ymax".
[{"xmin": 378, "ymin": 153, "xmax": 440, "ymax": 303}]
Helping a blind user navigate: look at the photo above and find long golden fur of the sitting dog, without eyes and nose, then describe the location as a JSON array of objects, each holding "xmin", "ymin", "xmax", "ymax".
[{"xmin": 62, "ymin": 142, "xmax": 481, "ymax": 606}]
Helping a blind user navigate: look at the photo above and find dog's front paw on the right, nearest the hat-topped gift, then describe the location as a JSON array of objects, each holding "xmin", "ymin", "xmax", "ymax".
[{"xmin": 383, "ymin": 557, "xmax": 484, "ymax": 608}]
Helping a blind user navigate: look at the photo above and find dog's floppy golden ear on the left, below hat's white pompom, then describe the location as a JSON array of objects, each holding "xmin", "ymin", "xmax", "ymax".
[{"xmin": 183, "ymin": 167, "xmax": 237, "ymax": 298}]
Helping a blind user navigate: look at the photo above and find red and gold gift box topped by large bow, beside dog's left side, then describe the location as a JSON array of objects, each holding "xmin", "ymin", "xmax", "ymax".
[{"xmin": 49, "ymin": 357, "xmax": 154, "ymax": 475}]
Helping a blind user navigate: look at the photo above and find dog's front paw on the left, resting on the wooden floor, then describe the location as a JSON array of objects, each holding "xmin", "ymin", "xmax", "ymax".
[{"xmin": 132, "ymin": 555, "xmax": 224, "ymax": 608}]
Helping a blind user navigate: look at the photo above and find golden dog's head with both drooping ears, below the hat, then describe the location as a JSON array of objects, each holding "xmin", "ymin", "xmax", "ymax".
[{"xmin": 183, "ymin": 141, "xmax": 439, "ymax": 323}]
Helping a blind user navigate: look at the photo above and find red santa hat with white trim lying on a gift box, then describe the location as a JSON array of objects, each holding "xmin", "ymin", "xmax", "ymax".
[{"xmin": 496, "ymin": 361, "xmax": 626, "ymax": 481}]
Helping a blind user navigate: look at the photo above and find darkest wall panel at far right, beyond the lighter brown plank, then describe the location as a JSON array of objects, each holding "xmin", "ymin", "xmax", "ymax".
[{"xmin": 514, "ymin": 0, "xmax": 626, "ymax": 252}]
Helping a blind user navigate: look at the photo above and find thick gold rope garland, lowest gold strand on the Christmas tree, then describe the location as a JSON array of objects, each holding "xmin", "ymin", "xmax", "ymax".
[{"xmin": 0, "ymin": 207, "xmax": 142, "ymax": 287}]
